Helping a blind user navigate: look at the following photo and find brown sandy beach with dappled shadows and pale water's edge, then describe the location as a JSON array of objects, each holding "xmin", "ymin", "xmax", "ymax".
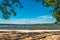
[{"xmin": 0, "ymin": 30, "xmax": 60, "ymax": 40}]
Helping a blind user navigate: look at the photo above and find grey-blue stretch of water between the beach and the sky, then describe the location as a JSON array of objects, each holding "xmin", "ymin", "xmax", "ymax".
[{"xmin": 0, "ymin": 24, "xmax": 60, "ymax": 30}]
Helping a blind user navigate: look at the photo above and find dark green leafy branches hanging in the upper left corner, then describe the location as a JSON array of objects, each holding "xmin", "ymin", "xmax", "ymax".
[{"xmin": 0, "ymin": 0, "xmax": 23, "ymax": 19}]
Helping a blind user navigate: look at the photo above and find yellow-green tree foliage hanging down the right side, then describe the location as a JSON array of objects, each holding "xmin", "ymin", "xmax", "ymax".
[{"xmin": 34, "ymin": 0, "xmax": 60, "ymax": 22}]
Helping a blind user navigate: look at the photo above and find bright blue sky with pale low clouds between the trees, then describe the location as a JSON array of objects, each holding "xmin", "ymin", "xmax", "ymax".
[{"xmin": 0, "ymin": 0, "xmax": 56, "ymax": 24}]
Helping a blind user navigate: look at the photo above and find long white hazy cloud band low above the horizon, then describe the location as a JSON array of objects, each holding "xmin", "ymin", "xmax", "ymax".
[{"xmin": 0, "ymin": 15, "xmax": 55, "ymax": 24}]
